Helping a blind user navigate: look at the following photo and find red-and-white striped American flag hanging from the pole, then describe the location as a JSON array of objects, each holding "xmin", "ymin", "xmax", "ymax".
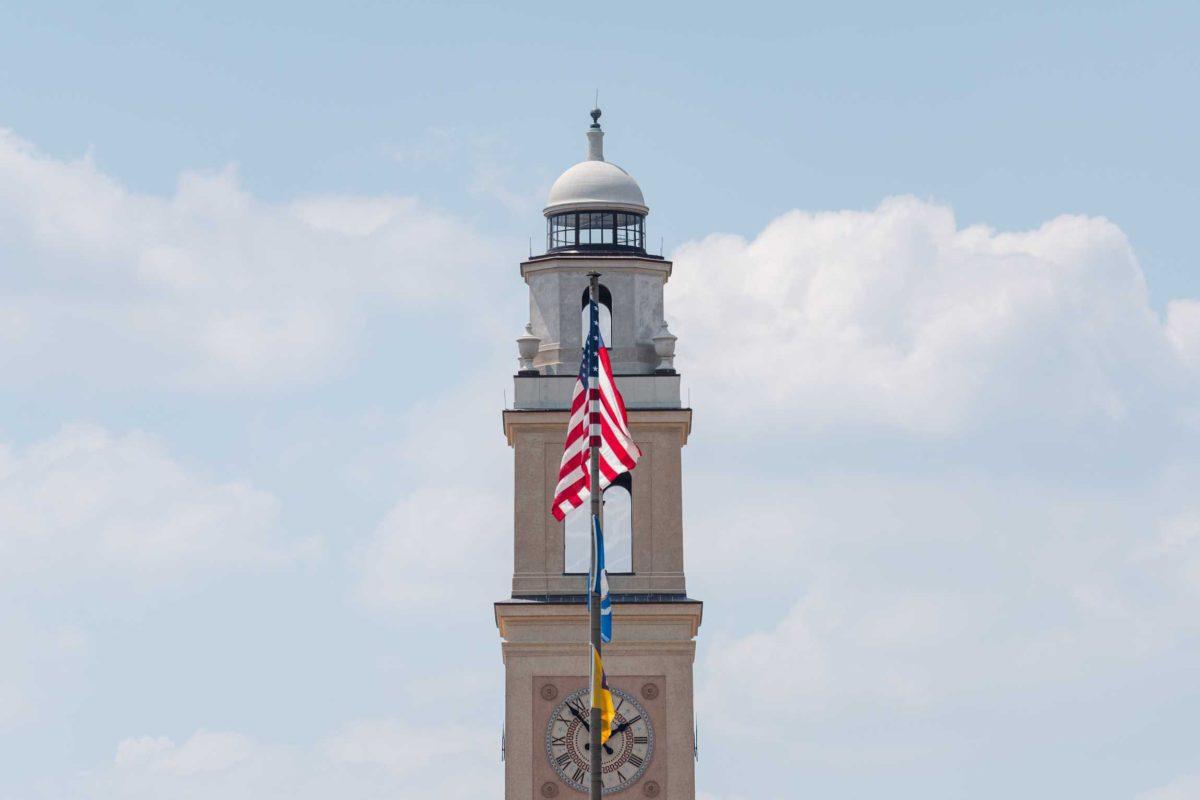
[{"xmin": 551, "ymin": 300, "xmax": 642, "ymax": 521}]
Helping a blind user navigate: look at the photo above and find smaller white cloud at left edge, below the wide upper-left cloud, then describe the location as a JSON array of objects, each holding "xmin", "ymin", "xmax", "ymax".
[{"xmin": 0, "ymin": 425, "xmax": 314, "ymax": 581}]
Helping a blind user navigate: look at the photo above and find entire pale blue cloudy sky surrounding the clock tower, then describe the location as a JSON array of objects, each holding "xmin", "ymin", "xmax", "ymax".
[{"xmin": 0, "ymin": 2, "xmax": 1200, "ymax": 800}]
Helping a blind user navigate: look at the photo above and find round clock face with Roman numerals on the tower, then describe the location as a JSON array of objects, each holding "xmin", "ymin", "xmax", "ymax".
[{"xmin": 546, "ymin": 688, "xmax": 654, "ymax": 794}]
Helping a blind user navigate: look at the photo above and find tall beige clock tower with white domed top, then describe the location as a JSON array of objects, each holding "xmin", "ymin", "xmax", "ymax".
[{"xmin": 494, "ymin": 109, "xmax": 702, "ymax": 800}]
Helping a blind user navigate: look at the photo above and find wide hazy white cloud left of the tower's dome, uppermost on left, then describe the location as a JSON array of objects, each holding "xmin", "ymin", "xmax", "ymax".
[{"xmin": 0, "ymin": 131, "xmax": 499, "ymax": 386}]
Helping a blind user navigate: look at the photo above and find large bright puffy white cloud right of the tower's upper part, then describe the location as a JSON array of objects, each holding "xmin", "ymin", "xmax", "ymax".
[{"xmin": 670, "ymin": 197, "xmax": 1196, "ymax": 434}]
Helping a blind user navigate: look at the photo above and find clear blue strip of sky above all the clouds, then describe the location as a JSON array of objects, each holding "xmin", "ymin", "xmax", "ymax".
[{"xmin": 9, "ymin": 2, "xmax": 1198, "ymax": 297}]
